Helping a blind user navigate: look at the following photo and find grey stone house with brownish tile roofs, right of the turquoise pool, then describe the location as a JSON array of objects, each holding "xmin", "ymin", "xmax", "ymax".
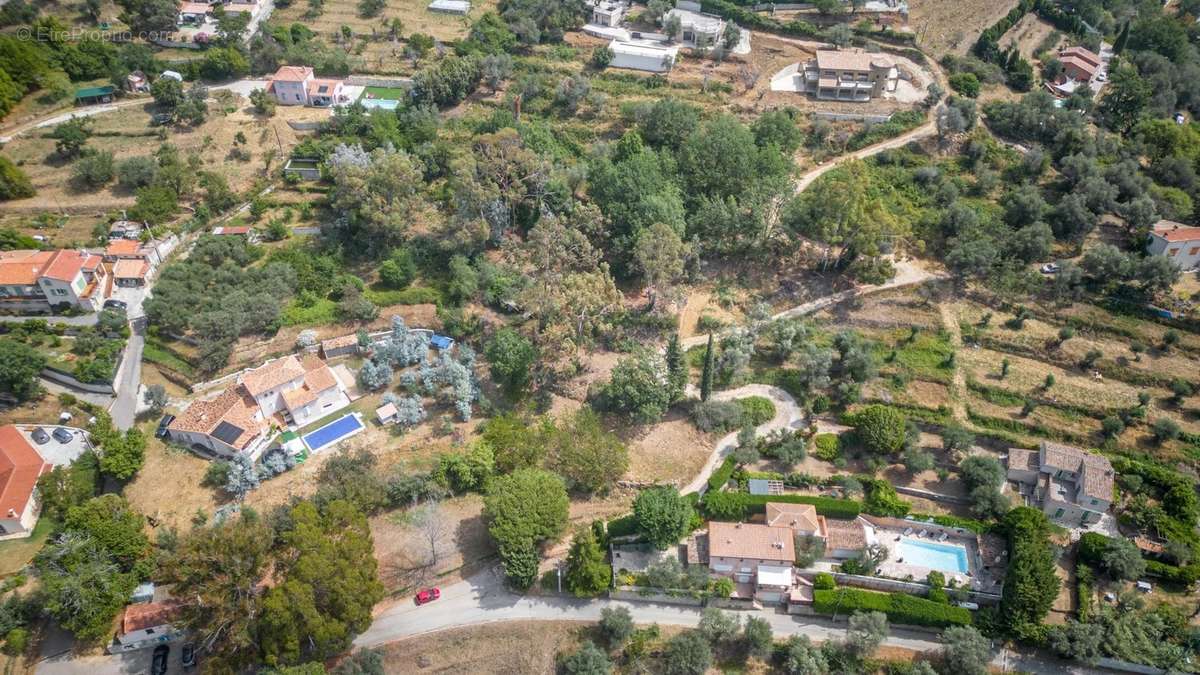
[{"xmin": 1008, "ymin": 441, "xmax": 1116, "ymax": 526}]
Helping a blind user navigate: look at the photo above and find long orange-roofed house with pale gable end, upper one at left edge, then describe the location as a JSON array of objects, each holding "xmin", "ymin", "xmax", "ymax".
[{"xmin": 0, "ymin": 250, "xmax": 110, "ymax": 313}]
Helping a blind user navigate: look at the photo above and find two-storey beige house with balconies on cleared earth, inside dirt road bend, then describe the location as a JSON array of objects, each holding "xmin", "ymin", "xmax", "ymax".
[{"xmin": 800, "ymin": 49, "xmax": 900, "ymax": 102}]
